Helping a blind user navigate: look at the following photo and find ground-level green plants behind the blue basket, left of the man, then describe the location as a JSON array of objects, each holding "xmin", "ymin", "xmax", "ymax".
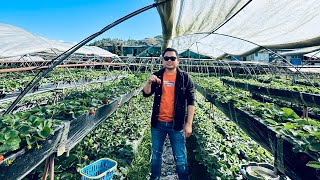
[{"xmin": 28, "ymin": 94, "xmax": 152, "ymax": 179}]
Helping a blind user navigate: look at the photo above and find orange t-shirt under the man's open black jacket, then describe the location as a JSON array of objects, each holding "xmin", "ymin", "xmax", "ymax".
[{"xmin": 158, "ymin": 72, "xmax": 177, "ymax": 122}]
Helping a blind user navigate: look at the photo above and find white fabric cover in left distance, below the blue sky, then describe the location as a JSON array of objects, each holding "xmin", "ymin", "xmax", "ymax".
[{"xmin": 0, "ymin": 23, "xmax": 116, "ymax": 58}]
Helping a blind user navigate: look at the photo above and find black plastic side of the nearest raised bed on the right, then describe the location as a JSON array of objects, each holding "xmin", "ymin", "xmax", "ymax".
[{"xmin": 197, "ymin": 86, "xmax": 320, "ymax": 179}]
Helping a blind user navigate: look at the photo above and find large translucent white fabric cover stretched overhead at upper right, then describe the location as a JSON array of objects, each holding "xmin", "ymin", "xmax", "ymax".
[{"xmin": 156, "ymin": 0, "xmax": 320, "ymax": 58}]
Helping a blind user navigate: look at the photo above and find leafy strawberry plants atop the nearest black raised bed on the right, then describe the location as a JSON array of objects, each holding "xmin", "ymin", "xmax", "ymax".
[{"xmin": 197, "ymin": 77, "xmax": 320, "ymax": 157}]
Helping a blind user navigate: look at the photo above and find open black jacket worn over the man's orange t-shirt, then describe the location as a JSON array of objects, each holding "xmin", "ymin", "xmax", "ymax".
[{"xmin": 142, "ymin": 68, "xmax": 194, "ymax": 131}]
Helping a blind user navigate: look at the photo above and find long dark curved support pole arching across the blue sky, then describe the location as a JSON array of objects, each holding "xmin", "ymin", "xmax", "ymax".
[{"xmin": 4, "ymin": 0, "xmax": 169, "ymax": 114}]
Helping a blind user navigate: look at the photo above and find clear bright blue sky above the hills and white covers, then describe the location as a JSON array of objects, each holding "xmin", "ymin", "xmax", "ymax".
[{"xmin": 0, "ymin": 0, "xmax": 162, "ymax": 42}]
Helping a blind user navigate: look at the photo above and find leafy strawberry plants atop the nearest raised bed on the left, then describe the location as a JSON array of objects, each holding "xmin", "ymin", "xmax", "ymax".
[{"xmin": 0, "ymin": 75, "xmax": 145, "ymax": 160}]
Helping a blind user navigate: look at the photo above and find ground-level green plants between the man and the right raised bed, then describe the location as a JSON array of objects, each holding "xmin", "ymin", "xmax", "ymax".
[{"xmin": 193, "ymin": 91, "xmax": 272, "ymax": 179}]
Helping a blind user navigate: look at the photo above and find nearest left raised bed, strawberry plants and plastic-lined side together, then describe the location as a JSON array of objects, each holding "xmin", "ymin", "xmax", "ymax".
[{"xmin": 0, "ymin": 76, "xmax": 146, "ymax": 179}]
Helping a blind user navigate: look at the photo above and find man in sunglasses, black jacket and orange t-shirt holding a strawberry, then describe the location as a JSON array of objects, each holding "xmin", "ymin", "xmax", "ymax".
[{"xmin": 142, "ymin": 48, "xmax": 194, "ymax": 180}]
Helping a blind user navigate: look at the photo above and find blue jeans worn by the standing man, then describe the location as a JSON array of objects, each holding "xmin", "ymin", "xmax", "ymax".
[{"xmin": 150, "ymin": 121, "xmax": 188, "ymax": 180}]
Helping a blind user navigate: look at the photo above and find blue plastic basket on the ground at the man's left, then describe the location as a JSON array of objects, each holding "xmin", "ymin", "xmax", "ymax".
[{"xmin": 80, "ymin": 158, "xmax": 118, "ymax": 180}]
